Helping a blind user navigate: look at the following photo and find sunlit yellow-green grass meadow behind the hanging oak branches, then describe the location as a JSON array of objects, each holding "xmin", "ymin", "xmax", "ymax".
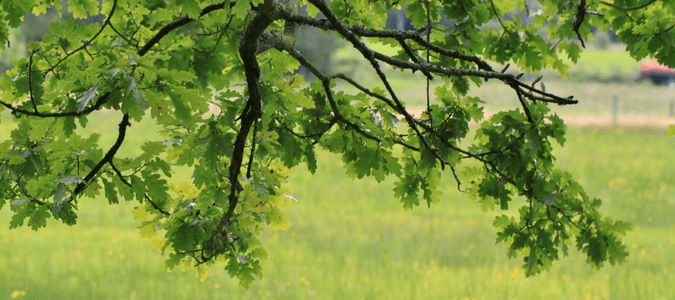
[{"xmin": 0, "ymin": 47, "xmax": 675, "ymax": 299}]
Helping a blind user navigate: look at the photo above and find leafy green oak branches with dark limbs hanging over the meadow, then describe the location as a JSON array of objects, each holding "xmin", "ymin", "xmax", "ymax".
[{"xmin": 0, "ymin": 0, "xmax": 675, "ymax": 286}]
